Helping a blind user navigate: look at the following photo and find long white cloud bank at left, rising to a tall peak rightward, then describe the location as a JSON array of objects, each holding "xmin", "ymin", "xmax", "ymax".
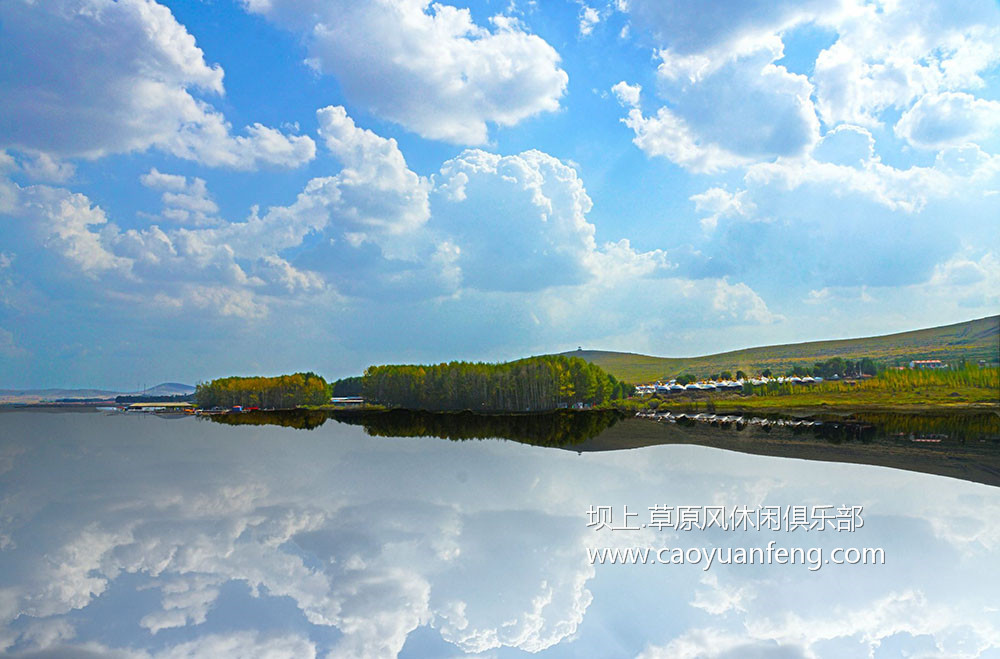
[{"xmin": 0, "ymin": 107, "xmax": 438, "ymax": 319}]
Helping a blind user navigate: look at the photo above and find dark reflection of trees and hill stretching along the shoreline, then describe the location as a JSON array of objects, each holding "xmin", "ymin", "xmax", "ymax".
[{"xmin": 206, "ymin": 410, "xmax": 1000, "ymax": 486}]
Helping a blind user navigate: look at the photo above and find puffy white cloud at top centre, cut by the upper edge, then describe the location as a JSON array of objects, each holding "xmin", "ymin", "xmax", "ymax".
[{"xmin": 244, "ymin": 0, "xmax": 568, "ymax": 144}]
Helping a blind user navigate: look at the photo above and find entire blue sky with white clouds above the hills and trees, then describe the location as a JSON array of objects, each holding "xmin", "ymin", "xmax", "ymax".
[{"xmin": 0, "ymin": 0, "xmax": 1000, "ymax": 390}]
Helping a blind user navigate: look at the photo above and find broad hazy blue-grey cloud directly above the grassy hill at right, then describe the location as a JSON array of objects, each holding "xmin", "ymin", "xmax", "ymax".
[{"xmin": 672, "ymin": 139, "xmax": 1000, "ymax": 304}]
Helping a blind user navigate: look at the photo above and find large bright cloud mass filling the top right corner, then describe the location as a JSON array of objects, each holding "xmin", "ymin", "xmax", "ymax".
[{"xmin": 620, "ymin": 0, "xmax": 1000, "ymax": 179}]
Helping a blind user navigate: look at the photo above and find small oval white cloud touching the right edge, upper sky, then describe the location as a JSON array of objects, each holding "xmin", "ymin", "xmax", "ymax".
[{"xmin": 895, "ymin": 92, "xmax": 1000, "ymax": 149}]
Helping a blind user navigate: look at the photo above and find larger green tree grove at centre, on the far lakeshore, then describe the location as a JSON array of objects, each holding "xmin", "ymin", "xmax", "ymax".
[{"xmin": 362, "ymin": 355, "xmax": 633, "ymax": 412}]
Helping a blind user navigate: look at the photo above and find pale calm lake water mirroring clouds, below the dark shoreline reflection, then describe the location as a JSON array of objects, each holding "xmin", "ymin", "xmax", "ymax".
[{"xmin": 0, "ymin": 412, "xmax": 1000, "ymax": 658}]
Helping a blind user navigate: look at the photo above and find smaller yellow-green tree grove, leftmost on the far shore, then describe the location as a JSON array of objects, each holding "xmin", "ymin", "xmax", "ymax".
[{"xmin": 194, "ymin": 373, "xmax": 330, "ymax": 409}]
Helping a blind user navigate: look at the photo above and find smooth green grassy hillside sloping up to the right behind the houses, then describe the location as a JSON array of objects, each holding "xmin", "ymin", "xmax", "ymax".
[{"xmin": 563, "ymin": 316, "xmax": 1000, "ymax": 384}]
